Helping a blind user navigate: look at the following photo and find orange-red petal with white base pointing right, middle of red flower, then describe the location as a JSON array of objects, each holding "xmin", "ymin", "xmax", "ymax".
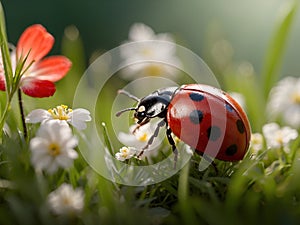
[{"xmin": 31, "ymin": 56, "xmax": 72, "ymax": 82}]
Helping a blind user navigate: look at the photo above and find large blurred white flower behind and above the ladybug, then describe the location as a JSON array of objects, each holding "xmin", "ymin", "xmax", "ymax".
[{"xmin": 120, "ymin": 23, "xmax": 180, "ymax": 78}]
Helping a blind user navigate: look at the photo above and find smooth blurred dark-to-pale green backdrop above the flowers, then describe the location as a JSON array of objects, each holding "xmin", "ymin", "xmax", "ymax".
[{"xmin": 2, "ymin": 0, "xmax": 300, "ymax": 76}]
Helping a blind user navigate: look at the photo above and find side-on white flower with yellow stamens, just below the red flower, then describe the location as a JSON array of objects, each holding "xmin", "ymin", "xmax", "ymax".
[{"xmin": 25, "ymin": 105, "xmax": 91, "ymax": 130}]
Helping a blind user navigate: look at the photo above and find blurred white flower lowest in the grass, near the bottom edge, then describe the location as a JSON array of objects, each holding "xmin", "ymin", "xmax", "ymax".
[{"xmin": 48, "ymin": 183, "xmax": 84, "ymax": 215}]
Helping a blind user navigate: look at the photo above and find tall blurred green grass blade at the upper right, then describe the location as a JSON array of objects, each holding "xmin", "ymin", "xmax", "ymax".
[{"xmin": 262, "ymin": 1, "xmax": 297, "ymax": 98}]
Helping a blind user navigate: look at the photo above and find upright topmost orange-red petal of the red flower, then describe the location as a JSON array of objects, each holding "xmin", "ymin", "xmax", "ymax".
[{"xmin": 16, "ymin": 24, "xmax": 54, "ymax": 65}]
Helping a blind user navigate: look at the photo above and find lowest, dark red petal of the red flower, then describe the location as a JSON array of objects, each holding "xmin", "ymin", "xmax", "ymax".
[{"xmin": 21, "ymin": 77, "xmax": 56, "ymax": 98}]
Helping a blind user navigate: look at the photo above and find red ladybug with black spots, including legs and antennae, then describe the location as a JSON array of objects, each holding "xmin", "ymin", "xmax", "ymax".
[{"xmin": 116, "ymin": 84, "xmax": 251, "ymax": 161}]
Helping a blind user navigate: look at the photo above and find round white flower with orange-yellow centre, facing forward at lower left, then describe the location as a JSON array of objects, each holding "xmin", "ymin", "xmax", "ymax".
[{"xmin": 30, "ymin": 120, "xmax": 78, "ymax": 174}]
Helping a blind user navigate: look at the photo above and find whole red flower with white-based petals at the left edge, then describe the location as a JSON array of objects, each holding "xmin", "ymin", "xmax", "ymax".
[{"xmin": 0, "ymin": 24, "xmax": 71, "ymax": 98}]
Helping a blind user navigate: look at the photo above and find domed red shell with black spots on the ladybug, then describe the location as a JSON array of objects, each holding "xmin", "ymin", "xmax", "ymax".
[{"xmin": 167, "ymin": 84, "xmax": 250, "ymax": 161}]
